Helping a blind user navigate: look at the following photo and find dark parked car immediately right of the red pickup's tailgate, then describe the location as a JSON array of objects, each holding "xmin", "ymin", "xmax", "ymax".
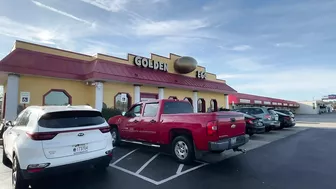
[{"xmin": 232, "ymin": 110, "xmax": 265, "ymax": 136}]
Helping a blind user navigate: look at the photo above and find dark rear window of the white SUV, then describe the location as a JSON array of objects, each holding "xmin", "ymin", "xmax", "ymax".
[{"xmin": 38, "ymin": 111, "xmax": 105, "ymax": 129}]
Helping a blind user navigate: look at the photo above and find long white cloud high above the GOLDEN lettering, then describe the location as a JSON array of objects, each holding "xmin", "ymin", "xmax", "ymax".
[{"xmin": 132, "ymin": 19, "xmax": 208, "ymax": 36}]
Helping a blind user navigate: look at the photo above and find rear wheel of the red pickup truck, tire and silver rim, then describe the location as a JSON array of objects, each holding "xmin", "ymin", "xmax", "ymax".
[{"xmin": 172, "ymin": 135, "xmax": 195, "ymax": 164}]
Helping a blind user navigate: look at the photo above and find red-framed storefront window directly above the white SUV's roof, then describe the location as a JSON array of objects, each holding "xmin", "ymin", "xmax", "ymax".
[{"xmin": 43, "ymin": 89, "xmax": 71, "ymax": 106}]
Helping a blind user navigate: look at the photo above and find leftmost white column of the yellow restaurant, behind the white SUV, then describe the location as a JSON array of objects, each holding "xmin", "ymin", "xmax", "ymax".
[{"xmin": 5, "ymin": 74, "xmax": 20, "ymax": 121}]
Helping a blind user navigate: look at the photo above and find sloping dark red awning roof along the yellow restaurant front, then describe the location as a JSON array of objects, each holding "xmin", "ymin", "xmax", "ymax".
[{"xmin": 0, "ymin": 49, "xmax": 236, "ymax": 94}]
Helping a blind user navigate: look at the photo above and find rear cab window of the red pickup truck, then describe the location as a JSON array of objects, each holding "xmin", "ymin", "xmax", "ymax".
[{"xmin": 163, "ymin": 101, "xmax": 194, "ymax": 114}]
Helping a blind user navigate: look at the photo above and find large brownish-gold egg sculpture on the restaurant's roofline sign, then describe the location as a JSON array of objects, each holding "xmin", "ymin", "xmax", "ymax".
[{"xmin": 174, "ymin": 56, "xmax": 197, "ymax": 74}]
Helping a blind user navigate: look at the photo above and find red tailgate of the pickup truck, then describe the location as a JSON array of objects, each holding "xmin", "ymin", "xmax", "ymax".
[{"xmin": 217, "ymin": 112, "xmax": 246, "ymax": 139}]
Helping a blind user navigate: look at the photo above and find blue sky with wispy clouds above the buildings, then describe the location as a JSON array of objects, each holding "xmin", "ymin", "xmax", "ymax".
[{"xmin": 0, "ymin": 0, "xmax": 336, "ymax": 100}]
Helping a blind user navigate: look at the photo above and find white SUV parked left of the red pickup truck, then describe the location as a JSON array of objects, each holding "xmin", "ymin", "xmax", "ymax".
[{"xmin": 2, "ymin": 106, "xmax": 113, "ymax": 188}]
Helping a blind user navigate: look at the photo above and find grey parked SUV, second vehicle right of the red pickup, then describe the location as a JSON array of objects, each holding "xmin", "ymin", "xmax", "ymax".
[{"xmin": 237, "ymin": 107, "xmax": 280, "ymax": 132}]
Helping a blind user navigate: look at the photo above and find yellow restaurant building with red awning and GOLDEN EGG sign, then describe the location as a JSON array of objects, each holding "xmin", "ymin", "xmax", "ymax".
[{"xmin": 0, "ymin": 41, "xmax": 236, "ymax": 120}]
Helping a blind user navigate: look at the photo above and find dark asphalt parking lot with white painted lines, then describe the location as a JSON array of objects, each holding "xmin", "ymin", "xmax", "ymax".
[{"xmin": 0, "ymin": 127, "xmax": 336, "ymax": 189}]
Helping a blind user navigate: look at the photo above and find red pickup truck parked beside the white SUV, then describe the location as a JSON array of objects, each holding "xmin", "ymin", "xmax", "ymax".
[{"xmin": 108, "ymin": 99, "xmax": 249, "ymax": 163}]
